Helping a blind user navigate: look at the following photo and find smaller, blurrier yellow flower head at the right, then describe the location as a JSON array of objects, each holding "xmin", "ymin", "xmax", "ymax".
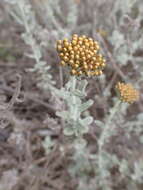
[{"xmin": 115, "ymin": 82, "xmax": 139, "ymax": 103}]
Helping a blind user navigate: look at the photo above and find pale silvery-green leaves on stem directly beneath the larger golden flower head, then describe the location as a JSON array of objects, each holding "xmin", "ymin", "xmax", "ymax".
[{"xmin": 57, "ymin": 77, "xmax": 93, "ymax": 136}]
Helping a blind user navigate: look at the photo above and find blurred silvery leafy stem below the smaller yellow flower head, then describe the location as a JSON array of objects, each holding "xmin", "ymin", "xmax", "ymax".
[{"xmin": 95, "ymin": 100, "xmax": 121, "ymax": 190}]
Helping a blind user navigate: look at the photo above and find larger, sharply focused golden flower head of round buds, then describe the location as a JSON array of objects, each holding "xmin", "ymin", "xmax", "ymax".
[{"xmin": 57, "ymin": 34, "xmax": 105, "ymax": 76}]
